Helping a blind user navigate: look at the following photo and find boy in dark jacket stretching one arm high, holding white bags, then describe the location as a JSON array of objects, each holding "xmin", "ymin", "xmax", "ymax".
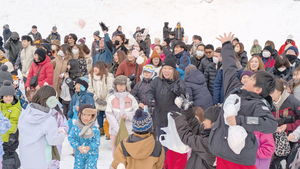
[{"xmin": 209, "ymin": 33, "xmax": 277, "ymax": 169}]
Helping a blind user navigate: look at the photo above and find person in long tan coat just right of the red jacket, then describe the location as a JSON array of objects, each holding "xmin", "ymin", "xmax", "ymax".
[{"xmin": 51, "ymin": 44, "xmax": 77, "ymax": 97}]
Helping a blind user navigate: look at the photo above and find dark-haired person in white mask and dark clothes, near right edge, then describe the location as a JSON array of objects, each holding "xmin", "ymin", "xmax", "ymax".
[{"xmin": 269, "ymin": 55, "xmax": 294, "ymax": 81}]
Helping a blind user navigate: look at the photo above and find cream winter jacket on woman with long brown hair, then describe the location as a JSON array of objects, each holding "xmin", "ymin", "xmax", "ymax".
[{"xmin": 88, "ymin": 73, "xmax": 114, "ymax": 111}]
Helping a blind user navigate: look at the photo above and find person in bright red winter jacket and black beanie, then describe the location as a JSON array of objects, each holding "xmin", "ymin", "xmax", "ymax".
[{"xmin": 25, "ymin": 48, "xmax": 53, "ymax": 91}]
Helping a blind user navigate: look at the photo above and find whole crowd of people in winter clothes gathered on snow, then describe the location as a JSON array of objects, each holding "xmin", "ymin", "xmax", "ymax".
[{"xmin": 0, "ymin": 22, "xmax": 300, "ymax": 169}]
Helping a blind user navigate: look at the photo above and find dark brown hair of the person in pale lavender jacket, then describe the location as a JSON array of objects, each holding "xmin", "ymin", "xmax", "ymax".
[{"xmin": 31, "ymin": 85, "xmax": 62, "ymax": 114}]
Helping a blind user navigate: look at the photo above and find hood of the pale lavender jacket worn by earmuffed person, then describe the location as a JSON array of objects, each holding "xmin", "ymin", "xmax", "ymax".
[{"xmin": 25, "ymin": 103, "xmax": 55, "ymax": 124}]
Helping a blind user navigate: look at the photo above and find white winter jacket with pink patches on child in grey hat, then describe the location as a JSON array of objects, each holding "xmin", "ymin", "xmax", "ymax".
[{"xmin": 105, "ymin": 91, "xmax": 139, "ymax": 135}]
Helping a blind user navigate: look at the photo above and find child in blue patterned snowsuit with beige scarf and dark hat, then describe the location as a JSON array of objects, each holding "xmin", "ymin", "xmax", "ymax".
[{"xmin": 68, "ymin": 104, "xmax": 100, "ymax": 169}]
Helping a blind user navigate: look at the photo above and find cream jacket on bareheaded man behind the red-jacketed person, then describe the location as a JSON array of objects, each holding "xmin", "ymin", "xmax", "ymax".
[{"xmin": 20, "ymin": 45, "xmax": 36, "ymax": 77}]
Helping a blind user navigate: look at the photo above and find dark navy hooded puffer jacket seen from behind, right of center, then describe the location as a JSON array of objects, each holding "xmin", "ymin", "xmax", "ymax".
[{"xmin": 185, "ymin": 70, "xmax": 213, "ymax": 110}]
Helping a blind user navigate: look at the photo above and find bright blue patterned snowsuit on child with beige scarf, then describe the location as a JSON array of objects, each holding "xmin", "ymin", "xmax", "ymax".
[{"xmin": 68, "ymin": 125, "xmax": 100, "ymax": 169}]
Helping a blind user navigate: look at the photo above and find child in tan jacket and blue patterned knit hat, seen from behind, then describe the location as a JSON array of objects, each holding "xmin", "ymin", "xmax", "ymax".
[{"xmin": 110, "ymin": 109, "xmax": 165, "ymax": 169}]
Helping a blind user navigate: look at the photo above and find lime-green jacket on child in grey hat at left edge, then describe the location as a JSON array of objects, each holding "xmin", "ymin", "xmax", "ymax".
[{"xmin": 0, "ymin": 99, "xmax": 21, "ymax": 142}]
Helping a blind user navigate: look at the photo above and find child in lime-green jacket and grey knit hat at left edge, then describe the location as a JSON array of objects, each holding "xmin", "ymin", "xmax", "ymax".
[{"xmin": 0, "ymin": 80, "xmax": 21, "ymax": 168}]
